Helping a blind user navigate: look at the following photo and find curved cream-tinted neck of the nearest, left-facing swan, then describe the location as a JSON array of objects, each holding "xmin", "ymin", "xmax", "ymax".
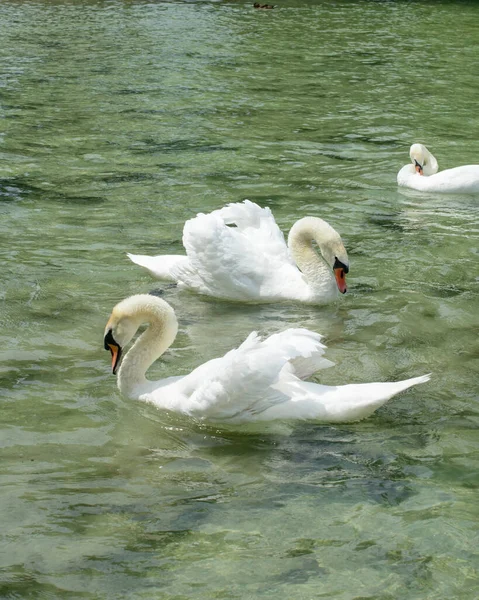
[{"xmin": 118, "ymin": 296, "xmax": 178, "ymax": 396}]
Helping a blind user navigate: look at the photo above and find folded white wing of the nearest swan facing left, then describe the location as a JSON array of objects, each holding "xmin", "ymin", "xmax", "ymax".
[{"xmin": 174, "ymin": 329, "xmax": 325, "ymax": 422}]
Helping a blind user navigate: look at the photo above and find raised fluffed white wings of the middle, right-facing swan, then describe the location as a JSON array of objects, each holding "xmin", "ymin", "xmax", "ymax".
[{"xmin": 175, "ymin": 200, "xmax": 307, "ymax": 300}]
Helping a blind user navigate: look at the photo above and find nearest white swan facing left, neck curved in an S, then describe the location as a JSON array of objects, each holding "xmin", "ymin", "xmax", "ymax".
[{"xmin": 104, "ymin": 294, "xmax": 429, "ymax": 423}]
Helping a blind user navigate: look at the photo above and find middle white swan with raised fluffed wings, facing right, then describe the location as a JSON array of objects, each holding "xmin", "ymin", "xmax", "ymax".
[{"xmin": 128, "ymin": 200, "xmax": 349, "ymax": 304}]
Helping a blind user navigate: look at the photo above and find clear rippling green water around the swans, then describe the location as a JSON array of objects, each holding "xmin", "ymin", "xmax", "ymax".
[{"xmin": 0, "ymin": 1, "xmax": 479, "ymax": 600}]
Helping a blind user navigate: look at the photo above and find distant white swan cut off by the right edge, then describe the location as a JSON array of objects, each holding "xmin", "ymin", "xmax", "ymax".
[{"xmin": 397, "ymin": 144, "xmax": 479, "ymax": 194}]
